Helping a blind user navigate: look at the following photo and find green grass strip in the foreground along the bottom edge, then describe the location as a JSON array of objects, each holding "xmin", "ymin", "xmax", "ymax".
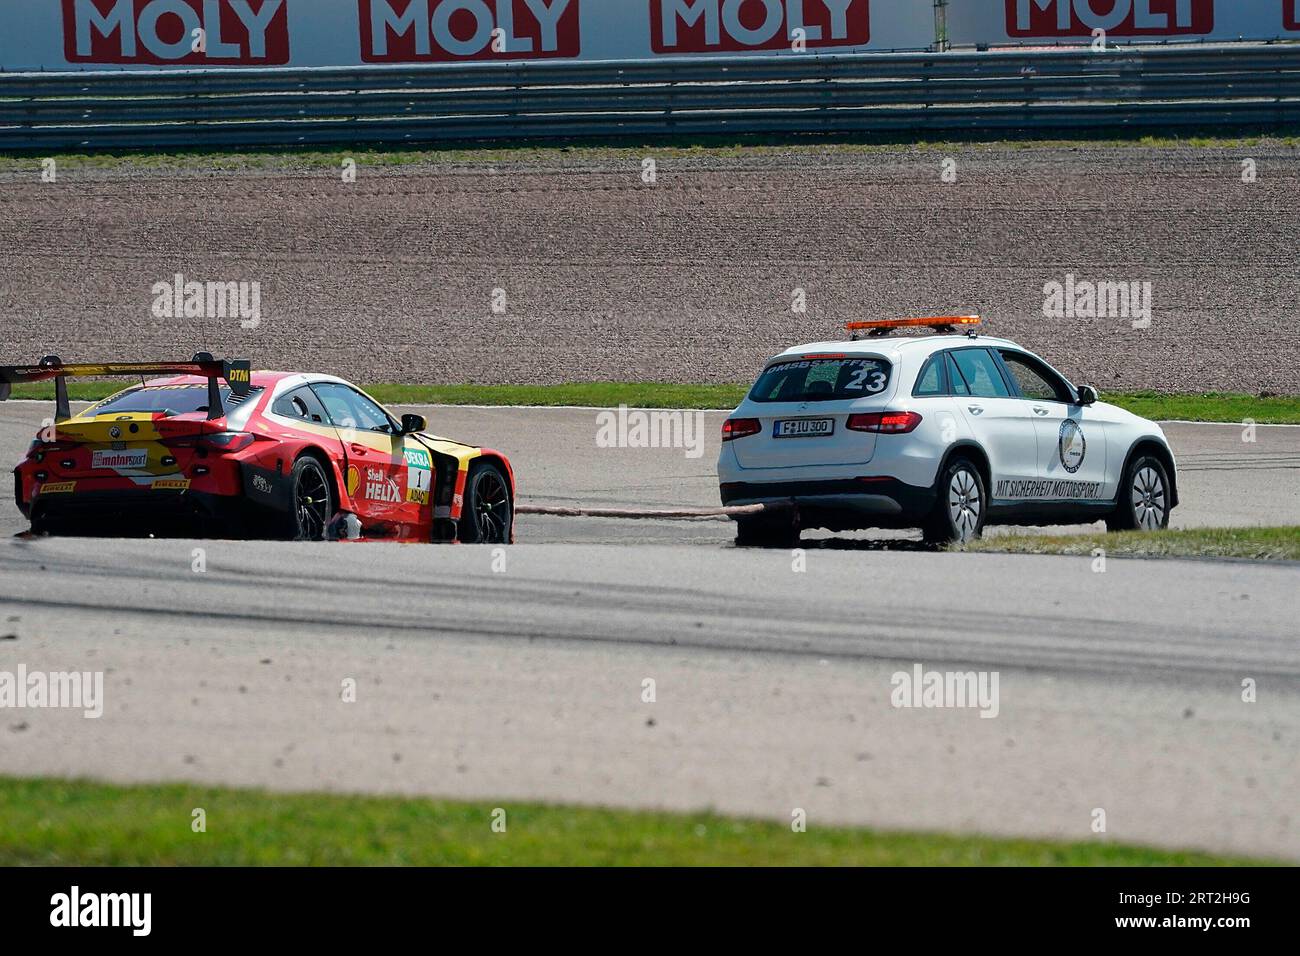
[{"xmin": 0, "ymin": 779, "xmax": 1260, "ymax": 866}]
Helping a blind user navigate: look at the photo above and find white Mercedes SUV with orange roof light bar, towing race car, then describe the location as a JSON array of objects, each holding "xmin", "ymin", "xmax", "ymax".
[{"xmin": 718, "ymin": 316, "xmax": 1178, "ymax": 546}]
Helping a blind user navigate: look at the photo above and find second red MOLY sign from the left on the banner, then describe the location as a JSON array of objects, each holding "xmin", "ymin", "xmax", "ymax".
[{"xmin": 358, "ymin": 0, "xmax": 582, "ymax": 62}]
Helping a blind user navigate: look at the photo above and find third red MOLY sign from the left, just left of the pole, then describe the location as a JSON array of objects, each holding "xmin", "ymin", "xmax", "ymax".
[{"xmin": 650, "ymin": 0, "xmax": 871, "ymax": 53}]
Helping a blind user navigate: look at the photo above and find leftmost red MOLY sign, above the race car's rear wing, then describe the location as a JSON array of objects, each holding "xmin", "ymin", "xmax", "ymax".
[{"xmin": 64, "ymin": 0, "xmax": 289, "ymax": 66}]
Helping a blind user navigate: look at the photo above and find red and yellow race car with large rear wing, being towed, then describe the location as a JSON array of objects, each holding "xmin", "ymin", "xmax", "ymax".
[{"xmin": 0, "ymin": 352, "xmax": 515, "ymax": 544}]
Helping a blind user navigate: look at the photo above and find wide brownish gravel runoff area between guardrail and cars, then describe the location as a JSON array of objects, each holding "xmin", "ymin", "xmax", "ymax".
[{"xmin": 0, "ymin": 140, "xmax": 1300, "ymax": 393}]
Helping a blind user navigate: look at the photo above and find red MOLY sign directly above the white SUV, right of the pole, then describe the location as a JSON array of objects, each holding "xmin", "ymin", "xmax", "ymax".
[{"xmin": 1006, "ymin": 0, "xmax": 1214, "ymax": 36}]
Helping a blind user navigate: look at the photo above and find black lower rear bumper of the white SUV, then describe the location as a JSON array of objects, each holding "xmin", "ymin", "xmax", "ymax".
[{"xmin": 720, "ymin": 479, "xmax": 935, "ymax": 531}]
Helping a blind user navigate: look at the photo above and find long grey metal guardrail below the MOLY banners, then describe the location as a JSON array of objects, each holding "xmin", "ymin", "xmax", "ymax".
[{"xmin": 0, "ymin": 46, "xmax": 1300, "ymax": 151}]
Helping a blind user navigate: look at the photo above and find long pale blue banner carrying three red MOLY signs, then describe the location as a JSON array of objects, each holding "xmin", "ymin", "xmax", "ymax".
[{"xmin": 0, "ymin": 0, "xmax": 935, "ymax": 72}]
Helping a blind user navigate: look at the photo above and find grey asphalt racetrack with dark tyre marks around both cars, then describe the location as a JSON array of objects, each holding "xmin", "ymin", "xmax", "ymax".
[{"xmin": 0, "ymin": 403, "xmax": 1300, "ymax": 860}]
